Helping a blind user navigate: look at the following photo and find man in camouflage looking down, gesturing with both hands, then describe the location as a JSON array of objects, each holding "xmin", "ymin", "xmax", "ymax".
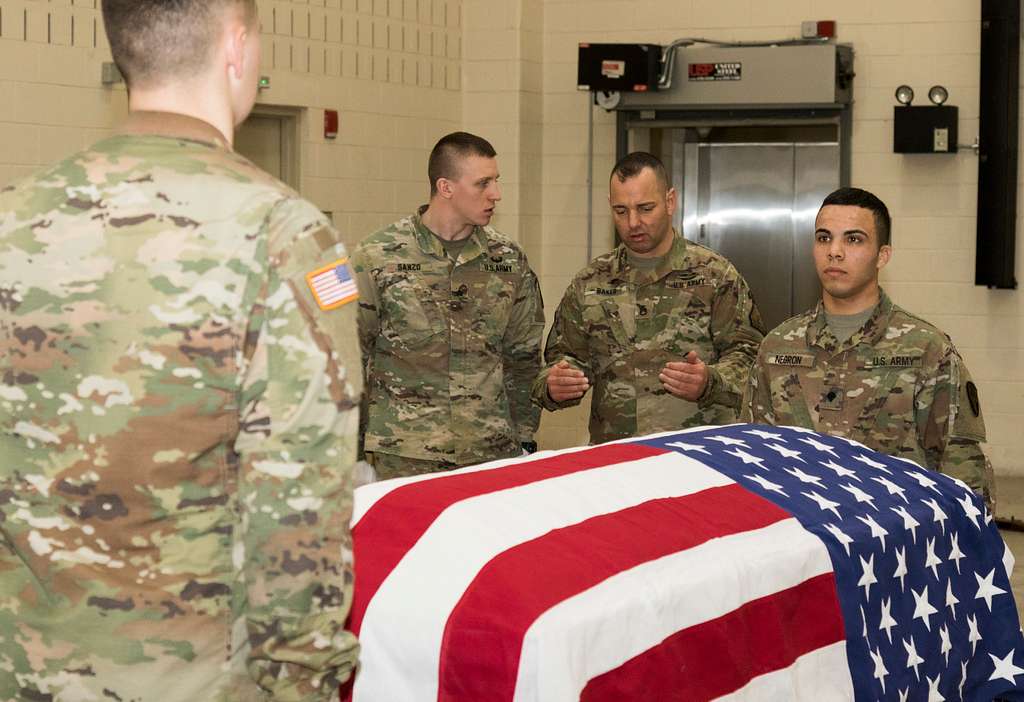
[{"xmin": 532, "ymin": 152, "xmax": 764, "ymax": 443}]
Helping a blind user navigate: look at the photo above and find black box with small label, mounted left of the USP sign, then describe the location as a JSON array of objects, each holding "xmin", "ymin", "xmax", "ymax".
[{"xmin": 577, "ymin": 43, "xmax": 662, "ymax": 92}]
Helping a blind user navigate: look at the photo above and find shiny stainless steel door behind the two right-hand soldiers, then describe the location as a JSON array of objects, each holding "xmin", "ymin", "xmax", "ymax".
[{"xmin": 672, "ymin": 142, "xmax": 840, "ymax": 328}]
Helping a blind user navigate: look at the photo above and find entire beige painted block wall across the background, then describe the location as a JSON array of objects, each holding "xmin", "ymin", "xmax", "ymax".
[{"xmin": 0, "ymin": 0, "xmax": 1024, "ymax": 474}]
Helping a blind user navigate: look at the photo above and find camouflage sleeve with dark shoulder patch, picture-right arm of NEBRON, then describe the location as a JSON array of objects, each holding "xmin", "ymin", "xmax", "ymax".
[{"xmin": 915, "ymin": 348, "xmax": 995, "ymax": 509}]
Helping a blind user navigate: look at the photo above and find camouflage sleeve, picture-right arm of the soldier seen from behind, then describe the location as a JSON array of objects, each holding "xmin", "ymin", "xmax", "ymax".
[{"xmin": 233, "ymin": 201, "xmax": 360, "ymax": 701}]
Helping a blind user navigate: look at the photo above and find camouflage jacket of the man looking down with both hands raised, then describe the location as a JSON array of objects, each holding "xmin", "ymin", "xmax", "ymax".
[{"xmin": 532, "ymin": 235, "xmax": 764, "ymax": 443}]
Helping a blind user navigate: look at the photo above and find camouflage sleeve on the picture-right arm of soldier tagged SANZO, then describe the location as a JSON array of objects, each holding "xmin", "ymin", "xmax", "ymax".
[{"xmin": 502, "ymin": 260, "xmax": 544, "ymax": 442}]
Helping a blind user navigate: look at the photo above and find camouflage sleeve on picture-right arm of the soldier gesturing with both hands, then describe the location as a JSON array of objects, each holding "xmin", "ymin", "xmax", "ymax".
[{"xmin": 697, "ymin": 266, "xmax": 765, "ymax": 409}]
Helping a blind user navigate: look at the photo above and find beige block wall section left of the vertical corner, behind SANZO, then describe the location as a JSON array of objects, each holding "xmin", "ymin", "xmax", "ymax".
[{"xmin": 0, "ymin": 0, "xmax": 463, "ymax": 250}]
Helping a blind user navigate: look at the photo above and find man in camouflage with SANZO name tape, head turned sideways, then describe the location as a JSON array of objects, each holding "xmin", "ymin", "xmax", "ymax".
[{"xmin": 352, "ymin": 132, "xmax": 544, "ymax": 478}]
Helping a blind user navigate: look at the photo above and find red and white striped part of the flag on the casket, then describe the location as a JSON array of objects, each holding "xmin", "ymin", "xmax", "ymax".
[{"xmin": 351, "ymin": 443, "xmax": 853, "ymax": 702}]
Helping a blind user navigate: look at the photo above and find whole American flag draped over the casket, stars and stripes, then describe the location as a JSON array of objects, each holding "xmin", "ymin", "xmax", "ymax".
[{"xmin": 351, "ymin": 425, "xmax": 1024, "ymax": 702}]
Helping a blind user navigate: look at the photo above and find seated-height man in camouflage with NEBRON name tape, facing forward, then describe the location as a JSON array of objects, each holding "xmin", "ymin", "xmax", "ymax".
[{"xmin": 742, "ymin": 188, "xmax": 993, "ymax": 503}]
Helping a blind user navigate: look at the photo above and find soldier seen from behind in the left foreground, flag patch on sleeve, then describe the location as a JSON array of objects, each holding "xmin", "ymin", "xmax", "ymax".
[{"xmin": 0, "ymin": 0, "xmax": 360, "ymax": 702}]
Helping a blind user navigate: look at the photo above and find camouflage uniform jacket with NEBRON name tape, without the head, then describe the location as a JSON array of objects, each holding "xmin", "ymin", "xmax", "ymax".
[{"xmin": 741, "ymin": 292, "xmax": 992, "ymax": 509}]
